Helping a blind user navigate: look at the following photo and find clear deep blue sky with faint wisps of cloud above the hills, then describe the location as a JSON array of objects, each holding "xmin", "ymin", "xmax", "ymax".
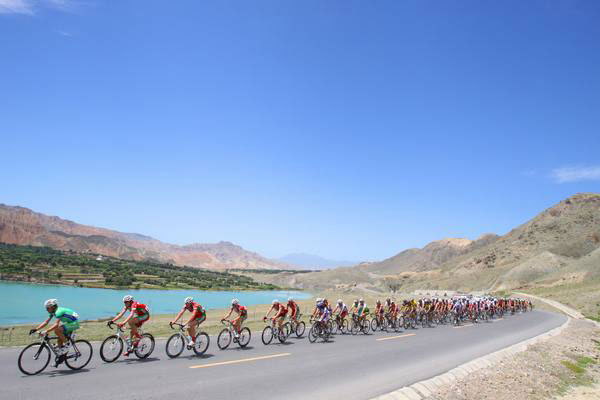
[{"xmin": 0, "ymin": 0, "xmax": 600, "ymax": 260}]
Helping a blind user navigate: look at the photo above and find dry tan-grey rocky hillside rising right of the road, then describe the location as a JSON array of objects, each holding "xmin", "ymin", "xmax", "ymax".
[{"xmin": 262, "ymin": 193, "xmax": 600, "ymax": 291}]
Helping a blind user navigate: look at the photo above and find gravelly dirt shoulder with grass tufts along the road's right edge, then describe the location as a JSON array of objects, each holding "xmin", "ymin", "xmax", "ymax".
[{"xmin": 429, "ymin": 320, "xmax": 600, "ymax": 400}]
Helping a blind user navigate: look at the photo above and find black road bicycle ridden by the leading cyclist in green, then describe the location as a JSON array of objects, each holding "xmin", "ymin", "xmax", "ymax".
[{"xmin": 18, "ymin": 333, "xmax": 94, "ymax": 375}]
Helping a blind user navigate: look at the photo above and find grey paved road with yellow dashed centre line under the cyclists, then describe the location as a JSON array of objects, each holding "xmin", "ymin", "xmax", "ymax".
[{"xmin": 0, "ymin": 311, "xmax": 565, "ymax": 400}]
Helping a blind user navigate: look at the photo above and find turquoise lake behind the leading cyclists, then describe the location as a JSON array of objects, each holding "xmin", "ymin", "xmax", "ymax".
[{"xmin": 0, "ymin": 282, "xmax": 310, "ymax": 326}]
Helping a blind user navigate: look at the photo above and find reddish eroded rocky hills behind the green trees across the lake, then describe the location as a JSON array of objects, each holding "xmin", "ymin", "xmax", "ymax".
[{"xmin": 0, "ymin": 204, "xmax": 288, "ymax": 270}]
